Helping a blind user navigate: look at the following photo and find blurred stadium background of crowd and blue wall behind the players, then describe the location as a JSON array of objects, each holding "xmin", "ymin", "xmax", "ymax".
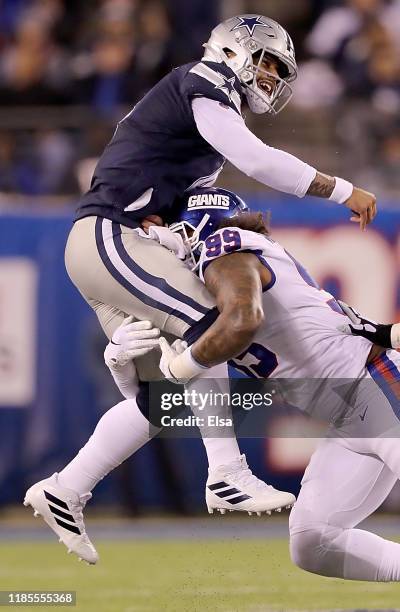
[{"xmin": 0, "ymin": 0, "xmax": 400, "ymax": 515}]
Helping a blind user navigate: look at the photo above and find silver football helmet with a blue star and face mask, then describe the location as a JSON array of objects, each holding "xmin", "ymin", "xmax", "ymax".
[{"xmin": 203, "ymin": 14, "xmax": 297, "ymax": 115}]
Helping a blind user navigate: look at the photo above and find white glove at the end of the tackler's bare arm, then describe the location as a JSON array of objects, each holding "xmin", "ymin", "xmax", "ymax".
[{"xmin": 159, "ymin": 336, "xmax": 207, "ymax": 384}]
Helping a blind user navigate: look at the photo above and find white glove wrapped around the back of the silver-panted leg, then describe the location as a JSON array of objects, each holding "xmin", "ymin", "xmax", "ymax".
[{"xmin": 104, "ymin": 316, "xmax": 160, "ymax": 368}]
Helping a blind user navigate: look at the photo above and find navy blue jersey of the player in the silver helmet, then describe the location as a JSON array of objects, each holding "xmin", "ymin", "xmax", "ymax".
[{"xmin": 75, "ymin": 61, "xmax": 242, "ymax": 228}]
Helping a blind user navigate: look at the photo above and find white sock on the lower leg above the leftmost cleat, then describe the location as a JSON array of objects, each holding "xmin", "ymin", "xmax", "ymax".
[{"xmin": 58, "ymin": 399, "xmax": 158, "ymax": 495}]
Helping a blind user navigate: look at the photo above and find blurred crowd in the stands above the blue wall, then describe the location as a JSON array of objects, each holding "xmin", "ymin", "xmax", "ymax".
[{"xmin": 0, "ymin": 0, "xmax": 400, "ymax": 196}]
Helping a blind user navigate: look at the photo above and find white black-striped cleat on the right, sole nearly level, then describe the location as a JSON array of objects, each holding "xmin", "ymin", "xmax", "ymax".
[{"xmin": 206, "ymin": 455, "xmax": 296, "ymax": 516}]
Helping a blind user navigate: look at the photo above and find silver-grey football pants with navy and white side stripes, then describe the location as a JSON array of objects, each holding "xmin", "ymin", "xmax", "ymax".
[{"xmin": 65, "ymin": 217, "xmax": 215, "ymax": 380}]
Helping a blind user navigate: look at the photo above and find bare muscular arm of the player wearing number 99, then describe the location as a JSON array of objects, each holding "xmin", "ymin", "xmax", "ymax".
[{"xmin": 192, "ymin": 253, "xmax": 271, "ymax": 367}]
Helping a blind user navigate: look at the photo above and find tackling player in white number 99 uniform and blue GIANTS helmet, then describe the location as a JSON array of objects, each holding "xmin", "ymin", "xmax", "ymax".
[{"xmin": 148, "ymin": 189, "xmax": 400, "ymax": 581}]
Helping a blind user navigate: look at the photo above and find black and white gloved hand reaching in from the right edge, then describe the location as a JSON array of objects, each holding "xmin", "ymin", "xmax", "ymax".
[{"xmin": 338, "ymin": 300, "xmax": 400, "ymax": 349}]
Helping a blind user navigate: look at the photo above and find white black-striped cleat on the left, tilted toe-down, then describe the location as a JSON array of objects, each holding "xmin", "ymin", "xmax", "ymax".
[{"xmin": 24, "ymin": 473, "xmax": 99, "ymax": 565}]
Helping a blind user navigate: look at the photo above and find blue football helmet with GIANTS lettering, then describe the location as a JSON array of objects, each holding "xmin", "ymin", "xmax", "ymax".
[{"xmin": 169, "ymin": 187, "xmax": 249, "ymax": 270}]
